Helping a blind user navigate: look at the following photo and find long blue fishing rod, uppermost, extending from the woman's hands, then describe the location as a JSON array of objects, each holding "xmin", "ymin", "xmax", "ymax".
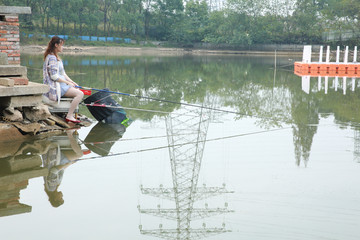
[{"xmin": 76, "ymin": 86, "xmax": 262, "ymax": 120}]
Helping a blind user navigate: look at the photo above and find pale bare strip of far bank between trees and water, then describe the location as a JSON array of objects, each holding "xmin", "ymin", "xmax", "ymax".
[{"xmin": 20, "ymin": 45, "xmax": 302, "ymax": 56}]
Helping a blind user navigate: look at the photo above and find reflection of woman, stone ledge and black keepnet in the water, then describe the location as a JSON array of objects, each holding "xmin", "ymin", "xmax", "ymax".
[{"xmin": 0, "ymin": 122, "xmax": 126, "ymax": 217}]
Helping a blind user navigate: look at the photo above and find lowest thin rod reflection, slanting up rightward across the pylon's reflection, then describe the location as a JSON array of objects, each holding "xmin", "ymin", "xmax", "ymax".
[{"xmin": 75, "ymin": 127, "xmax": 291, "ymax": 162}]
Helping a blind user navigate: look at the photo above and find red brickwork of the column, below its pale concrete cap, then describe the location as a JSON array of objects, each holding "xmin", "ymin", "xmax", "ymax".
[{"xmin": 0, "ymin": 15, "xmax": 20, "ymax": 65}]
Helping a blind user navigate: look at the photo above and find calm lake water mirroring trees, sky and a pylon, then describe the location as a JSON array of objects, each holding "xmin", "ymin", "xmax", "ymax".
[{"xmin": 0, "ymin": 55, "xmax": 360, "ymax": 240}]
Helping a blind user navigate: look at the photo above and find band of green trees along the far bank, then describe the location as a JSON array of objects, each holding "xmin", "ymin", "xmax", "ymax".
[{"xmin": 0, "ymin": 0, "xmax": 360, "ymax": 47}]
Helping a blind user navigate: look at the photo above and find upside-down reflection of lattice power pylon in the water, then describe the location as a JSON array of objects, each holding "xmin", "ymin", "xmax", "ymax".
[{"xmin": 139, "ymin": 96, "xmax": 232, "ymax": 240}]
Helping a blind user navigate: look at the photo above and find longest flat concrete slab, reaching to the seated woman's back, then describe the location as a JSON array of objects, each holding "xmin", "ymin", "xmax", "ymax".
[{"xmin": 0, "ymin": 82, "xmax": 49, "ymax": 97}]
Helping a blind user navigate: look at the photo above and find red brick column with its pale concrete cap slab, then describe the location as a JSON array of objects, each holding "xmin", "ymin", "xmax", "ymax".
[{"xmin": 0, "ymin": 6, "xmax": 31, "ymax": 65}]
